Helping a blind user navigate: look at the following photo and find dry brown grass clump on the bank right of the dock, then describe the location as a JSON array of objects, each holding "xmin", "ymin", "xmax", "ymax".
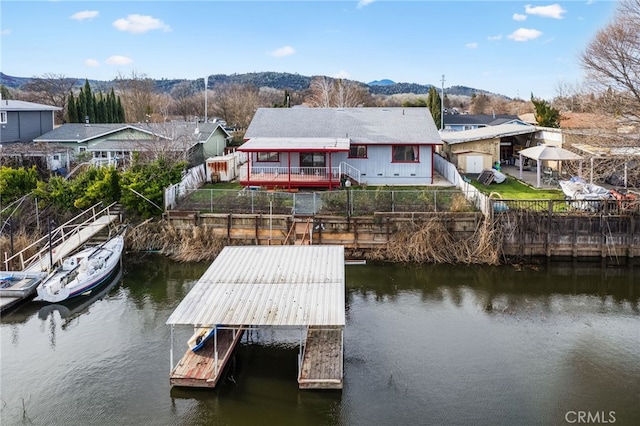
[{"xmin": 368, "ymin": 218, "xmax": 502, "ymax": 265}]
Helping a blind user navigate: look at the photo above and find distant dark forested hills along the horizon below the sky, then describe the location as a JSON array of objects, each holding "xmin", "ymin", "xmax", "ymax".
[{"xmin": 0, "ymin": 71, "xmax": 504, "ymax": 97}]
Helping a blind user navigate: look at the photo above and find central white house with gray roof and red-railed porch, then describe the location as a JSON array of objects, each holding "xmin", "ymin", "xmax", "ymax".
[{"xmin": 238, "ymin": 107, "xmax": 442, "ymax": 189}]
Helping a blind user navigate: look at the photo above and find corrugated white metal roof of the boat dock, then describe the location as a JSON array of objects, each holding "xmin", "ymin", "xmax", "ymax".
[{"xmin": 167, "ymin": 245, "xmax": 345, "ymax": 326}]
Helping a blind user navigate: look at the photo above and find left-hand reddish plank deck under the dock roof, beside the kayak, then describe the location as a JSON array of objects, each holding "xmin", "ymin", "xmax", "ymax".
[{"xmin": 169, "ymin": 329, "xmax": 244, "ymax": 388}]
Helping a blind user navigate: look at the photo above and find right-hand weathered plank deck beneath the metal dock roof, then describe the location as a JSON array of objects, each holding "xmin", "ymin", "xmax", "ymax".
[{"xmin": 298, "ymin": 327, "xmax": 344, "ymax": 389}]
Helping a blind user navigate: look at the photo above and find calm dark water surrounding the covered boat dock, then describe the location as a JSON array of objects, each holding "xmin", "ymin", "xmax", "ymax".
[{"xmin": 0, "ymin": 255, "xmax": 640, "ymax": 426}]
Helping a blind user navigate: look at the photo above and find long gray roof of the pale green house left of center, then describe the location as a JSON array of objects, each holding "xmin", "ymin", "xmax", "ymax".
[{"xmin": 34, "ymin": 122, "xmax": 229, "ymax": 143}]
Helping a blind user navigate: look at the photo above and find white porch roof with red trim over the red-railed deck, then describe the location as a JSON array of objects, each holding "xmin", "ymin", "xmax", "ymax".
[{"xmin": 238, "ymin": 138, "xmax": 351, "ymax": 152}]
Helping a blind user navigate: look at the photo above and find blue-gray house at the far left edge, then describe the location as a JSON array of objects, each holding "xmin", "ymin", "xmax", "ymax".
[{"xmin": 0, "ymin": 99, "xmax": 62, "ymax": 144}]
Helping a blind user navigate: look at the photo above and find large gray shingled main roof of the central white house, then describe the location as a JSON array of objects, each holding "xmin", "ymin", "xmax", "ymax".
[{"xmin": 244, "ymin": 107, "xmax": 442, "ymax": 145}]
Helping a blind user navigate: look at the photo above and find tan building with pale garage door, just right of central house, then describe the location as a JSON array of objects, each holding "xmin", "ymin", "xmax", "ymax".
[{"xmin": 442, "ymin": 123, "xmax": 536, "ymax": 173}]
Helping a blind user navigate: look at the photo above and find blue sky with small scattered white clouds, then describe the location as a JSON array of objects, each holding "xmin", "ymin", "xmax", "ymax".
[{"xmin": 0, "ymin": 0, "xmax": 616, "ymax": 100}]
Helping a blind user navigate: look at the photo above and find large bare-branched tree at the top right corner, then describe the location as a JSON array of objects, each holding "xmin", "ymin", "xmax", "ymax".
[{"xmin": 580, "ymin": 0, "xmax": 640, "ymax": 121}]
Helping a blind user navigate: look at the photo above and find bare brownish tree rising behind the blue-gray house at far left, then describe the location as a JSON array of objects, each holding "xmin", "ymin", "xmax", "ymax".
[{"xmin": 22, "ymin": 74, "xmax": 76, "ymax": 124}]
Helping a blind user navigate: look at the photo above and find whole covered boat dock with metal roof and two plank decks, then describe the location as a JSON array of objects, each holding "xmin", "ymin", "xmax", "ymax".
[{"xmin": 167, "ymin": 245, "xmax": 345, "ymax": 389}]
